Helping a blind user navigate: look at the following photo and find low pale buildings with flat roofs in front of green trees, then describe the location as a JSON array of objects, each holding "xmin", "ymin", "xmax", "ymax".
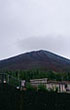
[{"xmin": 30, "ymin": 78, "xmax": 70, "ymax": 92}]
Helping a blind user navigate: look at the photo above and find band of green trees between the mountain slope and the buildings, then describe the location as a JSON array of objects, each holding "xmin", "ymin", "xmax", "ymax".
[{"xmin": 3, "ymin": 69, "xmax": 70, "ymax": 81}]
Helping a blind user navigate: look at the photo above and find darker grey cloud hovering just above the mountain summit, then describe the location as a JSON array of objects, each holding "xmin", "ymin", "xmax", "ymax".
[{"xmin": 18, "ymin": 36, "xmax": 70, "ymax": 56}]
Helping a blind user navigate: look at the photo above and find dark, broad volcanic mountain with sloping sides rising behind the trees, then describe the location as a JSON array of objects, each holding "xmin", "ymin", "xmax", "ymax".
[{"xmin": 0, "ymin": 50, "xmax": 70, "ymax": 72}]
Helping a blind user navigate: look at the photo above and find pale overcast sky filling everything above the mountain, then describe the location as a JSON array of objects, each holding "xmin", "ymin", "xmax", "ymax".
[{"xmin": 0, "ymin": 0, "xmax": 70, "ymax": 59}]
